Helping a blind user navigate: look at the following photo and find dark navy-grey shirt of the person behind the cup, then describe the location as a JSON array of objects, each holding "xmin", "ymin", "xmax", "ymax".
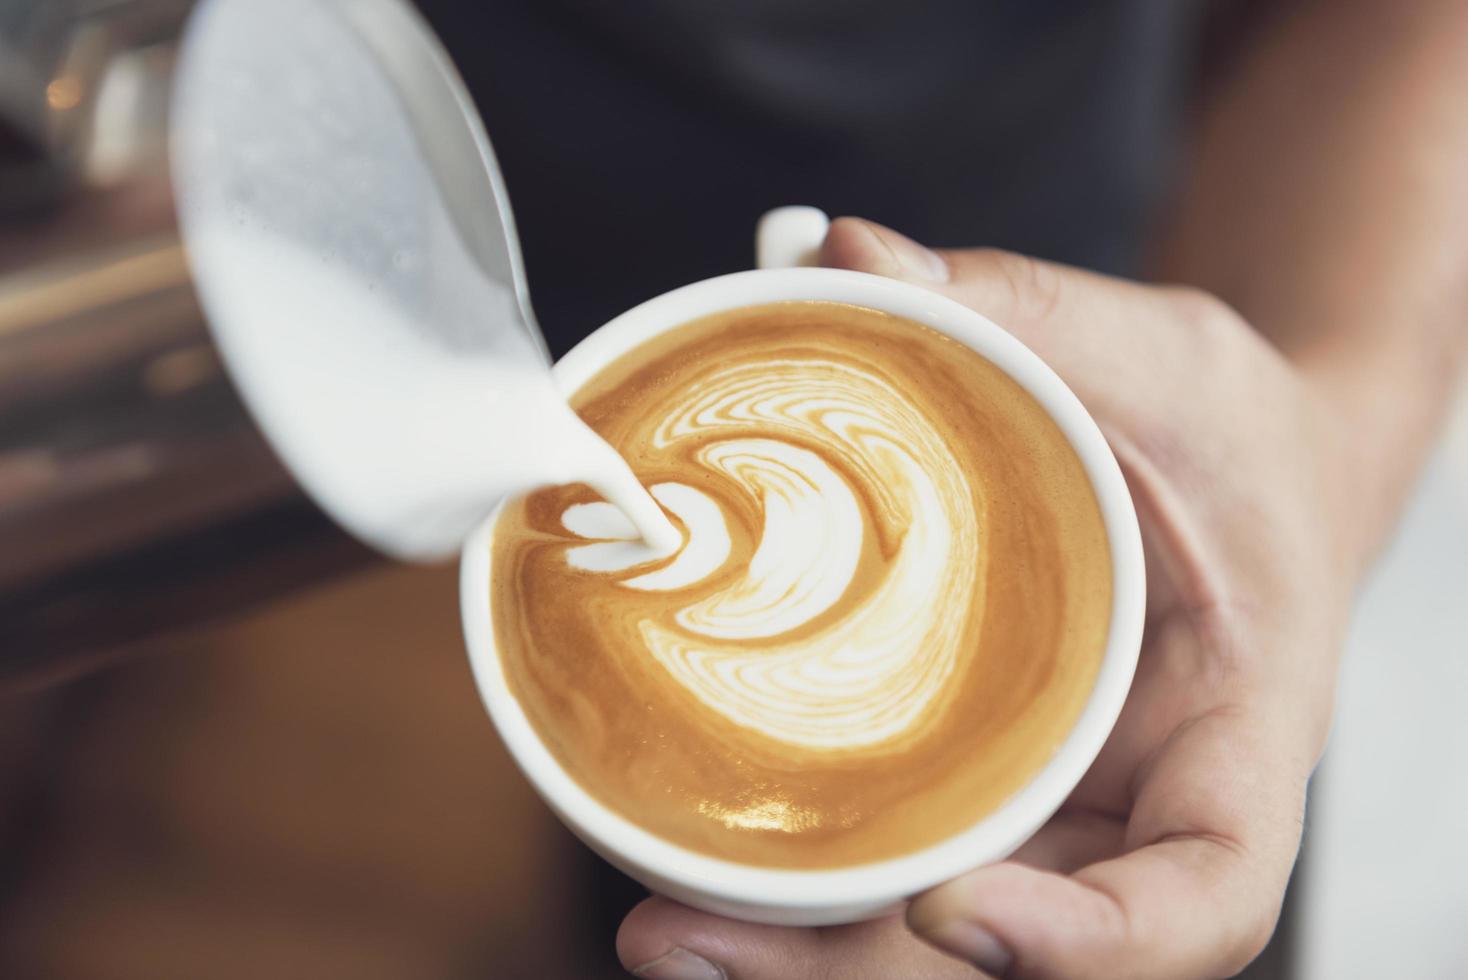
[{"xmin": 421, "ymin": 0, "xmax": 1195, "ymax": 352}]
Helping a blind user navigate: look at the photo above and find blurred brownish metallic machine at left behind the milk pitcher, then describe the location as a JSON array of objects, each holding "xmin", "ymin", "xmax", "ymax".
[{"xmin": 0, "ymin": 0, "xmax": 374, "ymax": 690}]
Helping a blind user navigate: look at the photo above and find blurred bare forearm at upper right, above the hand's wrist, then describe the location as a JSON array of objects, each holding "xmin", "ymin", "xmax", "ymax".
[{"xmin": 1155, "ymin": 0, "xmax": 1468, "ymax": 575}]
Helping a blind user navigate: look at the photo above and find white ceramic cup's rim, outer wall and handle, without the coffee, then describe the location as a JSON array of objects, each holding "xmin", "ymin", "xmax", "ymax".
[{"xmin": 461, "ymin": 214, "xmax": 1145, "ymax": 926}]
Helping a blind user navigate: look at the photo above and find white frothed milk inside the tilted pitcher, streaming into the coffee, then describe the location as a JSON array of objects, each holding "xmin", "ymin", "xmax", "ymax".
[{"xmin": 189, "ymin": 223, "xmax": 680, "ymax": 555}]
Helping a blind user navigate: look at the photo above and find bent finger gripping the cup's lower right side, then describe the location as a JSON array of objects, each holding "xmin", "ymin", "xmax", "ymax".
[{"xmin": 907, "ymin": 713, "xmax": 1304, "ymax": 980}]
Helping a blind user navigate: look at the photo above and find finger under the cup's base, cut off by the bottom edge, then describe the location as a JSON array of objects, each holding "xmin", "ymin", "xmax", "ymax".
[{"xmin": 617, "ymin": 896, "xmax": 982, "ymax": 980}]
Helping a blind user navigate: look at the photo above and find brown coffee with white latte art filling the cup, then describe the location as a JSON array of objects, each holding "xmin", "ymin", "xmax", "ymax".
[{"xmin": 489, "ymin": 302, "xmax": 1111, "ymax": 869}]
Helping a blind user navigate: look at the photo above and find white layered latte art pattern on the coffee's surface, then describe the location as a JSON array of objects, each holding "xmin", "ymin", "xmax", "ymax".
[{"xmin": 562, "ymin": 358, "xmax": 982, "ymax": 750}]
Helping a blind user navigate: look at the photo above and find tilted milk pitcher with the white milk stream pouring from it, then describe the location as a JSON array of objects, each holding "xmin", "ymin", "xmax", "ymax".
[{"xmin": 173, "ymin": 0, "xmax": 681, "ymax": 559}]
